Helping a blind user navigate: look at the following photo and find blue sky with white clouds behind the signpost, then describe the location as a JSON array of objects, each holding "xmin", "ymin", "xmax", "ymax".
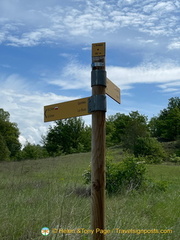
[{"xmin": 0, "ymin": 0, "xmax": 180, "ymax": 144}]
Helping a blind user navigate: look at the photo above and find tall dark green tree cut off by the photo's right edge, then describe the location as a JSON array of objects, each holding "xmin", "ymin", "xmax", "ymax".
[{"xmin": 149, "ymin": 97, "xmax": 180, "ymax": 141}]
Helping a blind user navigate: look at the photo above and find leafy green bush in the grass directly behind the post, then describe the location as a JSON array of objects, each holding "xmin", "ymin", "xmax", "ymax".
[{"xmin": 83, "ymin": 152, "xmax": 168, "ymax": 195}]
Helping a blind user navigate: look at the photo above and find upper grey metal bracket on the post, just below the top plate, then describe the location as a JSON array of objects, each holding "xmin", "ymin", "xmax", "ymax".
[{"xmin": 91, "ymin": 70, "xmax": 106, "ymax": 87}]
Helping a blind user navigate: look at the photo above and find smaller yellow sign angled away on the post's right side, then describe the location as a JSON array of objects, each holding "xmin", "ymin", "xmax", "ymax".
[{"xmin": 106, "ymin": 78, "xmax": 121, "ymax": 103}]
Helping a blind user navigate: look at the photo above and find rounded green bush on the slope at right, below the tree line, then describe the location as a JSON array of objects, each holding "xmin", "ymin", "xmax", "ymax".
[{"xmin": 134, "ymin": 137, "xmax": 165, "ymax": 163}]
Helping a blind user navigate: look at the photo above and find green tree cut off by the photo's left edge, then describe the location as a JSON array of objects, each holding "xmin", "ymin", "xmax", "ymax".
[{"xmin": 0, "ymin": 109, "xmax": 21, "ymax": 158}]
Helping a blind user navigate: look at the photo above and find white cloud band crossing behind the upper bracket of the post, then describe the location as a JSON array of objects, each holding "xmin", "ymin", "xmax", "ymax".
[{"xmin": 48, "ymin": 62, "xmax": 180, "ymax": 93}]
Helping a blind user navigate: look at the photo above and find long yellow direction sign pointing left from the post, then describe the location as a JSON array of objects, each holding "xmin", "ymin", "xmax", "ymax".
[{"xmin": 44, "ymin": 97, "xmax": 91, "ymax": 122}]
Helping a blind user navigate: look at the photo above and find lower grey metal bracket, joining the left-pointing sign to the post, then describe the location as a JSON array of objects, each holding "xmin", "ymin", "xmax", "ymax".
[{"xmin": 88, "ymin": 94, "xmax": 106, "ymax": 113}]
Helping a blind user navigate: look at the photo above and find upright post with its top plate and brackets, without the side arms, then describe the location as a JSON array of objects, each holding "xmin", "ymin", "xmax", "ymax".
[{"xmin": 91, "ymin": 43, "xmax": 106, "ymax": 240}]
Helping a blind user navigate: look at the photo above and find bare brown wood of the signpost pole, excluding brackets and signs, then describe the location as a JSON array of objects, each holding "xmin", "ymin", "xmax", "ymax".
[{"xmin": 91, "ymin": 42, "xmax": 106, "ymax": 240}]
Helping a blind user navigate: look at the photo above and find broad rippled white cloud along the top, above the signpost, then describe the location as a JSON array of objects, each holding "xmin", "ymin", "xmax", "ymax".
[{"xmin": 0, "ymin": 0, "xmax": 180, "ymax": 46}]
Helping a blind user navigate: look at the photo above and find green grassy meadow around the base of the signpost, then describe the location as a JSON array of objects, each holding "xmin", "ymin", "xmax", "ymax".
[{"xmin": 0, "ymin": 150, "xmax": 180, "ymax": 240}]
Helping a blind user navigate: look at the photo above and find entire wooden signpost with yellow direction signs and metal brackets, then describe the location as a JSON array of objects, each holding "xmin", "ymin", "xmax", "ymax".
[{"xmin": 44, "ymin": 42, "xmax": 120, "ymax": 240}]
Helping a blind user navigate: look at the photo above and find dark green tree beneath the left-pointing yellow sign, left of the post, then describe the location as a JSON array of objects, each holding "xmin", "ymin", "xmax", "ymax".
[{"xmin": 43, "ymin": 118, "xmax": 91, "ymax": 156}]
